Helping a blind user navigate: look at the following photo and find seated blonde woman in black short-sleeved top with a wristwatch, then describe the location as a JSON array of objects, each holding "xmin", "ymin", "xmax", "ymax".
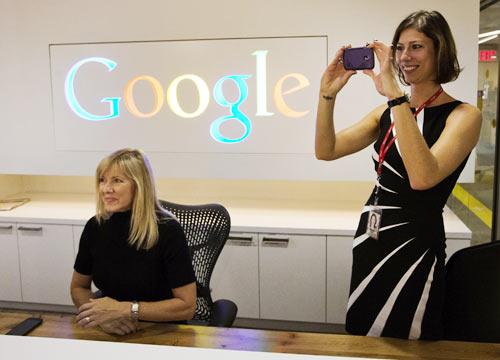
[{"xmin": 71, "ymin": 149, "xmax": 196, "ymax": 335}]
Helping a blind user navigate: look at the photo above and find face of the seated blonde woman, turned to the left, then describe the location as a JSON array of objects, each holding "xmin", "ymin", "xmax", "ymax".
[{"xmin": 99, "ymin": 166, "xmax": 135, "ymax": 214}]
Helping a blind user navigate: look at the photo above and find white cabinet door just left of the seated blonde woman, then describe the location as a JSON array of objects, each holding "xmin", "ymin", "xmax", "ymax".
[{"xmin": 17, "ymin": 224, "xmax": 74, "ymax": 305}]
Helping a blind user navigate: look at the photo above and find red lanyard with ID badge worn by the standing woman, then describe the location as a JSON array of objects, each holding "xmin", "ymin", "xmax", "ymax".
[{"xmin": 366, "ymin": 87, "xmax": 443, "ymax": 240}]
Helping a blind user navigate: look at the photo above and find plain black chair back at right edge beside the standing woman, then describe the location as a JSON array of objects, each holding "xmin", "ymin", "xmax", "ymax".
[{"xmin": 444, "ymin": 241, "xmax": 500, "ymax": 342}]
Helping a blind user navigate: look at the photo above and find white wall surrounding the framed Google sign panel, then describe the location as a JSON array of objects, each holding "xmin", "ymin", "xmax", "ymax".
[{"xmin": 0, "ymin": 0, "xmax": 479, "ymax": 180}]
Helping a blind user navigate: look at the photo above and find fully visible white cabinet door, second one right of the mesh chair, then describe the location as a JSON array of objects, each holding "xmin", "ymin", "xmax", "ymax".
[{"xmin": 259, "ymin": 234, "xmax": 326, "ymax": 322}]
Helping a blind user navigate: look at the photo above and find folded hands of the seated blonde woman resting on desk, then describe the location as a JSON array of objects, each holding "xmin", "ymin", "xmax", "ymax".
[{"xmin": 76, "ymin": 297, "xmax": 130, "ymax": 328}]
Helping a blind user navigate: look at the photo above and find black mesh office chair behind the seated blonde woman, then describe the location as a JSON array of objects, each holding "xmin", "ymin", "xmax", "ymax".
[{"xmin": 160, "ymin": 200, "xmax": 238, "ymax": 327}]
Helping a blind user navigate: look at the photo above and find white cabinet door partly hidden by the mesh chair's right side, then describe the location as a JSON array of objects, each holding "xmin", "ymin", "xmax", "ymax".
[{"xmin": 211, "ymin": 233, "xmax": 259, "ymax": 319}]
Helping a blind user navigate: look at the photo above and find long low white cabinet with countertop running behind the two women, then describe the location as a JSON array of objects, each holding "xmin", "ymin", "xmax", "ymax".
[{"xmin": 0, "ymin": 193, "xmax": 471, "ymax": 324}]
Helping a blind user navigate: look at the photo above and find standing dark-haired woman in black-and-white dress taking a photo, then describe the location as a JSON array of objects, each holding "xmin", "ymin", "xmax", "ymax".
[{"xmin": 315, "ymin": 11, "xmax": 481, "ymax": 339}]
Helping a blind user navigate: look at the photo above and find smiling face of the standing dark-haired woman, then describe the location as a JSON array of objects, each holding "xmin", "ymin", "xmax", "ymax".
[{"xmin": 395, "ymin": 28, "xmax": 436, "ymax": 85}]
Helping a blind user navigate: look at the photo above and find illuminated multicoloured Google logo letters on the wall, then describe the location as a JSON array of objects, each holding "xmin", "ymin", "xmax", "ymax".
[{"xmin": 64, "ymin": 50, "xmax": 310, "ymax": 144}]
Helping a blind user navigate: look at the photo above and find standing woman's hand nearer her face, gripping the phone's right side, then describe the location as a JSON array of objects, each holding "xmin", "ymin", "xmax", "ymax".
[{"xmin": 363, "ymin": 40, "xmax": 403, "ymax": 98}]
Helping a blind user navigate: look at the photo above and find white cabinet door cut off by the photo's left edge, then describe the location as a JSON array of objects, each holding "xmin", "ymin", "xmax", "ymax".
[{"xmin": 0, "ymin": 223, "xmax": 22, "ymax": 301}]
